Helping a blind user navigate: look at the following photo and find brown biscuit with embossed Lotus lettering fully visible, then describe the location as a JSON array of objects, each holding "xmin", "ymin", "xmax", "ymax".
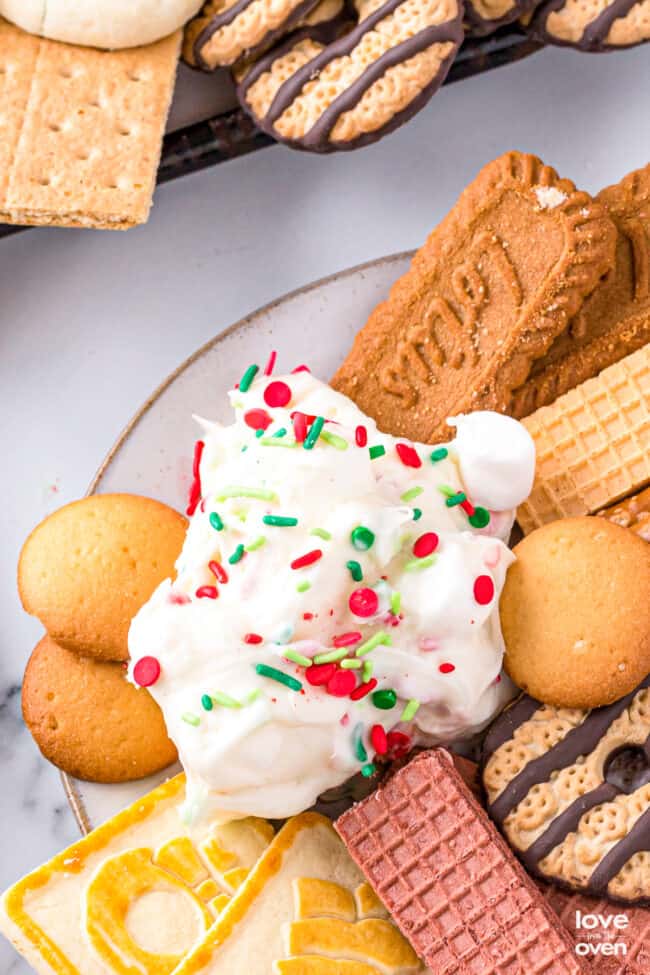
[{"xmin": 333, "ymin": 152, "xmax": 615, "ymax": 442}]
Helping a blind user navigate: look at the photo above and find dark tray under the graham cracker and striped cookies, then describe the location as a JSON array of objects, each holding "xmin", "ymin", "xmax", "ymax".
[{"xmin": 0, "ymin": 25, "xmax": 542, "ymax": 237}]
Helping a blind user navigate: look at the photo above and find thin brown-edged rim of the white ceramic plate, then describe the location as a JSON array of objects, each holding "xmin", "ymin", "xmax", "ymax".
[{"xmin": 59, "ymin": 249, "xmax": 415, "ymax": 836}]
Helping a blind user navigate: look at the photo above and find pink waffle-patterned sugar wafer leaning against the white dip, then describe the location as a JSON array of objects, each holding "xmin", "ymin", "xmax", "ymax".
[{"xmin": 336, "ymin": 749, "xmax": 587, "ymax": 975}]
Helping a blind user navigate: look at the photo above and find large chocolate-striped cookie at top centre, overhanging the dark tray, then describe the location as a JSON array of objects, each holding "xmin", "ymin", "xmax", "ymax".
[{"xmin": 237, "ymin": 0, "xmax": 463, "ymax": 152}]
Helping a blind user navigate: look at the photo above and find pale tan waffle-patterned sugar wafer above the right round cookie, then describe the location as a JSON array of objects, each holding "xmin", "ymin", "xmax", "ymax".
[{"xmin": 517, "ymin": 345, "xmax": 650, "ymax": 534}]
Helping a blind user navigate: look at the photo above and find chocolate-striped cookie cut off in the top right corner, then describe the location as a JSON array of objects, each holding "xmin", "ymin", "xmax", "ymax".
[{"xmin": 532, "ymin": 0, "xmax": 650, "ymax": 51}]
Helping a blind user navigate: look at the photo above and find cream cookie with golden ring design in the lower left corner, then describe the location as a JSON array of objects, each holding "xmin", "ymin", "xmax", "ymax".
[{"xmin": 0, "ymin": 775, "xmax": 273, "ymax": 975}]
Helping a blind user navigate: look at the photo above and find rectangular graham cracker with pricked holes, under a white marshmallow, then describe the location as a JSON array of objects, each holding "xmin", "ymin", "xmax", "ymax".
[{"xmin": 0, "ymin": 18, "xmax": 181, "ymax": 230}]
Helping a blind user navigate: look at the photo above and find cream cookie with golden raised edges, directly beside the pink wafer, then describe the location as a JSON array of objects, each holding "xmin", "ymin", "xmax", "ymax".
[{"xmin": 174, "ymin": 813, "xmax": 432, "ymax": 975}]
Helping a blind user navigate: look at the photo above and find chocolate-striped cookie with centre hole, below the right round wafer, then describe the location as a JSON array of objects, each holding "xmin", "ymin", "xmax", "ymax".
[{"xmin": 483, "ymin": 680, "xmax": 650, "ymax": 903}]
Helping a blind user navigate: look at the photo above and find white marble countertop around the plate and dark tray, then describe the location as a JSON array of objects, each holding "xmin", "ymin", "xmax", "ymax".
[{"xmin": 0, "ymin": 40, "xmax": 650, "ymax": 975}]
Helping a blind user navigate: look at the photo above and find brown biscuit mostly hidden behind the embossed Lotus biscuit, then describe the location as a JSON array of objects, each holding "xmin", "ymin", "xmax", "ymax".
[{"xmin": 509, "ymin": 165, "xmax": 650, "ymax": 418}]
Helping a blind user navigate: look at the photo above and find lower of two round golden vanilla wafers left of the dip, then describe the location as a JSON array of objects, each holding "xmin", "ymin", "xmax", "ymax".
[{"xmin": 23, "ymin": 636, "xmax": 177, "ymax": 782}]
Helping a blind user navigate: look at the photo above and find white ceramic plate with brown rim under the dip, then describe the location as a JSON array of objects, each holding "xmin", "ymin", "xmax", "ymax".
[{"xmin": 63, "ymin": 253, "xmax": 411, "ymax": 832}]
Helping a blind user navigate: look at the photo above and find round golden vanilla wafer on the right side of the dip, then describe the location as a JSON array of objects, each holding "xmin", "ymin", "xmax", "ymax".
[{"xmin": 500, "ymin": 518, "xmax": 650, "ymax": 708}]
